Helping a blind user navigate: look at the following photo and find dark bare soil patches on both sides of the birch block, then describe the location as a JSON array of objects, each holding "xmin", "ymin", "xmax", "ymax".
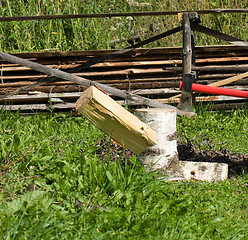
[{"xmin": 95, "ymin": 138, "xmax": 248, "ymax": 177}]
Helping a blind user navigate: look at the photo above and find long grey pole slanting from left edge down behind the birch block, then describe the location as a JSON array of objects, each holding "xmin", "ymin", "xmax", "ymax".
[{"xmin": 0, "ymin": 51, "xmax": 193, "ymax": 116}]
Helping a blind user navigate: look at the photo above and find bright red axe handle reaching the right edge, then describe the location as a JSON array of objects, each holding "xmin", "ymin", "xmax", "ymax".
[{"xmin": 179, "ymin": 81, "xmax": 248, "ymax": 98}]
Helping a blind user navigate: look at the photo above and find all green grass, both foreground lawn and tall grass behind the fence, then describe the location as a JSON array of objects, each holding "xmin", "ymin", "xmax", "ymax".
[{"xmin": 0, "ymin": 0, "xmax": 248, "ymax": 240}]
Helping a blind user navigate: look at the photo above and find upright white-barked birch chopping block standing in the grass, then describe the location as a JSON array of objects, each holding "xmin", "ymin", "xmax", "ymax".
[{"xmin": 137, "ymin": 108, "xmax": 178, "ymax": 171}]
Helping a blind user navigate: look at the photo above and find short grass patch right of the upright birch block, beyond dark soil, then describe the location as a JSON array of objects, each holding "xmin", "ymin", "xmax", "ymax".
[{"xmin": 178, "ymin": 106, "xmax": 248, "ymax": 154}]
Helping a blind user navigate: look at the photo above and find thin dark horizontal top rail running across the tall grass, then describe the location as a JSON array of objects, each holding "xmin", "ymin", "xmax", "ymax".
[{"xmin": 0, "ymin": 9, "xmax": 248, "ymax": 22}]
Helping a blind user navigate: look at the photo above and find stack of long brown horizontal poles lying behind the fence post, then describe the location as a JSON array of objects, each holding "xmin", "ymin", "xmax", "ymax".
[{"xmin": 0, "ymin": 45, "xmax": 248, "ymax": 111}]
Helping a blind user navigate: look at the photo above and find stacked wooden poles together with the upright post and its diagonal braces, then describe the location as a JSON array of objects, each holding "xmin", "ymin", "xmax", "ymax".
[{"xmin": 0, "ymin": 10, "xmax": 248, "ymax": 111}]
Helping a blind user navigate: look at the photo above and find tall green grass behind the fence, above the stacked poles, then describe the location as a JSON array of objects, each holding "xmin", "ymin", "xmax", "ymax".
[{"xmin": 0, "ymin": 0, "xmax": 248, "ymax": 52}]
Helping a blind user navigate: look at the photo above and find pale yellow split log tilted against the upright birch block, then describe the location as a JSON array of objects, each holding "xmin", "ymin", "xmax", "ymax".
[{"xmin": 76, "ymin": 86, "xmax": 156, "ymax": 154}]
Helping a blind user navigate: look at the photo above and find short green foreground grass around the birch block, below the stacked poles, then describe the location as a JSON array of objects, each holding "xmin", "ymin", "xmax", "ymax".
[{"xmin": 0, "ymin": 109, "xmax": 248, "ymax": 240}]
